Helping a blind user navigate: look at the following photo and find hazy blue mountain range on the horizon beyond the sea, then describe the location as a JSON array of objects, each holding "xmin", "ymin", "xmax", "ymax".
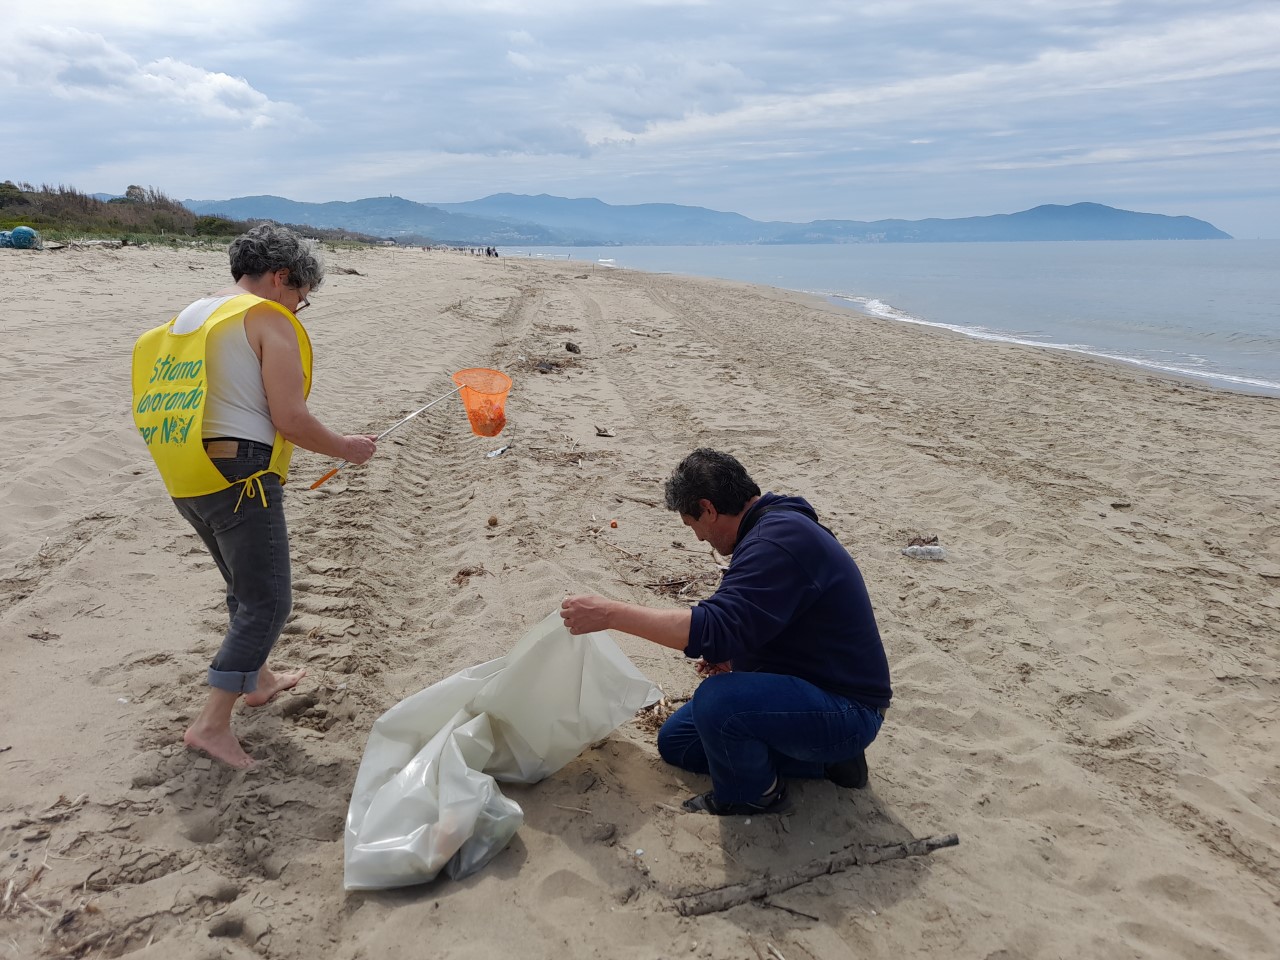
[{"xmin": 172, "ymin": 193, "xmax": 1230, "ymax": 247}]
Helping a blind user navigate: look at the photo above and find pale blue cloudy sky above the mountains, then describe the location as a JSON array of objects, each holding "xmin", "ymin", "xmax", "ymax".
[{"xmin": 0, "ymin": 0, "xmax": 1280, "ymax": 238}]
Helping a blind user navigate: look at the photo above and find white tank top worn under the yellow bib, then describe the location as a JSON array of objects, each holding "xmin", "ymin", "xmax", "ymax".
[{"xmin": 173, "ymin": 294, "xmax": 275, "ymax": 445}]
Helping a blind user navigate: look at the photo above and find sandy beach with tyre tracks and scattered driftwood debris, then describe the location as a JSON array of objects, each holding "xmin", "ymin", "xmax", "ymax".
[{"xmin": 0, "ymin": 241, "xmax": 1280, "ymax": 960}]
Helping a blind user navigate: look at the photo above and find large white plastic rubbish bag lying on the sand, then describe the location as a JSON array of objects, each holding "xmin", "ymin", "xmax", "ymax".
[{"xmin": 343, "ymin": 612, "xmax": 660, "ymax": 890}]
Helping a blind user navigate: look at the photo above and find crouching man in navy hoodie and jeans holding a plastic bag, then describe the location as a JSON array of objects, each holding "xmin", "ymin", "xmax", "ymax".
[{"xmin": 561, "ymin": 448, "xmax": 892, "ymax": 815}]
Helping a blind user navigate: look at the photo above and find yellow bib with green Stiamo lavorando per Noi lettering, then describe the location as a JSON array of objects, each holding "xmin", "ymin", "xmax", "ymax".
[{"xmin": 133, "ymin": 293, "xmax": 311, "ymax": 509}]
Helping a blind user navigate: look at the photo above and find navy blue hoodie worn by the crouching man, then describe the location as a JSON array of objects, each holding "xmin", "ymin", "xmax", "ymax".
[{"xmin": 685, "ymin": 493, "xmax": 893, "ymax": 707}]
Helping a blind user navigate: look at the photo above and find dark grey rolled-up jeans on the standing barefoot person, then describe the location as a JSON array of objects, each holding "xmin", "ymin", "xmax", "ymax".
[{"xmin": 174, "ymin": 440, "xmax": 293, "ymax": 694}]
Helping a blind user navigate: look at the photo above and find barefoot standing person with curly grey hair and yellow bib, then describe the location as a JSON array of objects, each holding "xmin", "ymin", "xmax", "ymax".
[{"xmin": 133, "ymin": 224, "xmax": 375, "ymax": 769}]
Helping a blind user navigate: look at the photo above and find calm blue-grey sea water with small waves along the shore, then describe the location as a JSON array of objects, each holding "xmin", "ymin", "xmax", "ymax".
[{"xmin": 502, "ymin": 241, "xmax": 1280, "ymax": 396}]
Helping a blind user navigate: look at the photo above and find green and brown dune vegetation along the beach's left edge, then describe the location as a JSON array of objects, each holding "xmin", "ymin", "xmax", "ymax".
[{"xmin": 0, "ymin": 180, "xmax": 380, "ymax": 244}]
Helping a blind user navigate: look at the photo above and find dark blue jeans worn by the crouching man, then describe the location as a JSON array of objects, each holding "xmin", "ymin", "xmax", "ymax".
[{"xmin": 658, "ymin": 673, "xmax": 884, "ymax": 804}]
